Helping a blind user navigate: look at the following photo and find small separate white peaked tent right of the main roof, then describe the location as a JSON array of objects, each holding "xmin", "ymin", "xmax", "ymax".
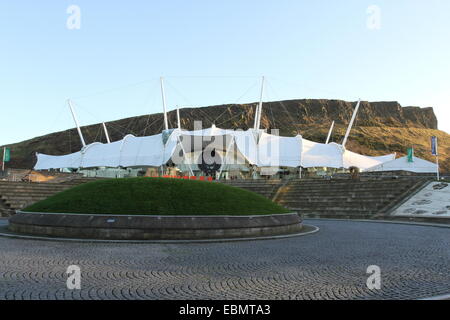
[{"xmin": 366, "ymin": 156, "xmax": 437, "ymax": 173}]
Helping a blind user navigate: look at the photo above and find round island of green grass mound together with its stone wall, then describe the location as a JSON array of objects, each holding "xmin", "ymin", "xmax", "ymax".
[{"xmin": 9, "ymin": 178, "xmax": 302, "ymax": 240}]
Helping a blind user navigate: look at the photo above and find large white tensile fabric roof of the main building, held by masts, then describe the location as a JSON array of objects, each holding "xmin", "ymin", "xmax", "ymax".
[{"xmin": 34, "ymin": 126, "xmax": 395, "ymax": 170}]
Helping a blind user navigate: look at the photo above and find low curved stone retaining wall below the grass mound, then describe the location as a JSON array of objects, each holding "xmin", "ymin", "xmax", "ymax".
[{"xmin": 9, "ymin": 211, "xmax": 302, "ymax": 240}]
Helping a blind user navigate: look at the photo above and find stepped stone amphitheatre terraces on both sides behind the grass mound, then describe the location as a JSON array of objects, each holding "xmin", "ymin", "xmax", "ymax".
[{"xmin": 0, "ymin": 177, "xmax": 428, "ymax": 219}]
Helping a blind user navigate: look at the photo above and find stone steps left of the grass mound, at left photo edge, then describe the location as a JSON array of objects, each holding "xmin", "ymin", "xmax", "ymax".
[{"xmin": 0, "ymin": 178, "xmax": 102, "ymax": 217}]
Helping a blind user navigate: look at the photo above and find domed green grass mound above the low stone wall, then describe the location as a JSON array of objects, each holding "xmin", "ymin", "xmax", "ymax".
[{"xmin": 24, "ymin": 178, "xmax": 289, "ymax": 215}]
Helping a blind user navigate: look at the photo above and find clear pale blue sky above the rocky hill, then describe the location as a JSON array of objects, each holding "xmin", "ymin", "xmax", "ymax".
[{"xmin": 0, "ymin": 0, "xmax": 450, "ymax": 145}]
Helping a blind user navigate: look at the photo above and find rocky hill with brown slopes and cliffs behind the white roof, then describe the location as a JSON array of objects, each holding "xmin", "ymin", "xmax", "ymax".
[{"xmin": 1, "ymin": 99, "xmax": 450, "ymax": 172}]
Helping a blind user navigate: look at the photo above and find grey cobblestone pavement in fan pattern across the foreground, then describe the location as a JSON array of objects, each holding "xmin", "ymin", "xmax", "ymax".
[{"xmin": 0, "ymin": 220, "xmax": 450, "ymax": 299}]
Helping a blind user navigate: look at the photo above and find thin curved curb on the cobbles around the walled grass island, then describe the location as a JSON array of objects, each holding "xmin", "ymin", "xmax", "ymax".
[{"xmin": 0, "ymin": 224, "xmax": 320, "ymax": 244}]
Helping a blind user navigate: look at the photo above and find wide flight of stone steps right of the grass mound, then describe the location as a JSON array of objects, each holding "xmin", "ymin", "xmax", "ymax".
[{"xmin": 227, "ymin": 179, "xmax": 427, "ymax": 219}]
